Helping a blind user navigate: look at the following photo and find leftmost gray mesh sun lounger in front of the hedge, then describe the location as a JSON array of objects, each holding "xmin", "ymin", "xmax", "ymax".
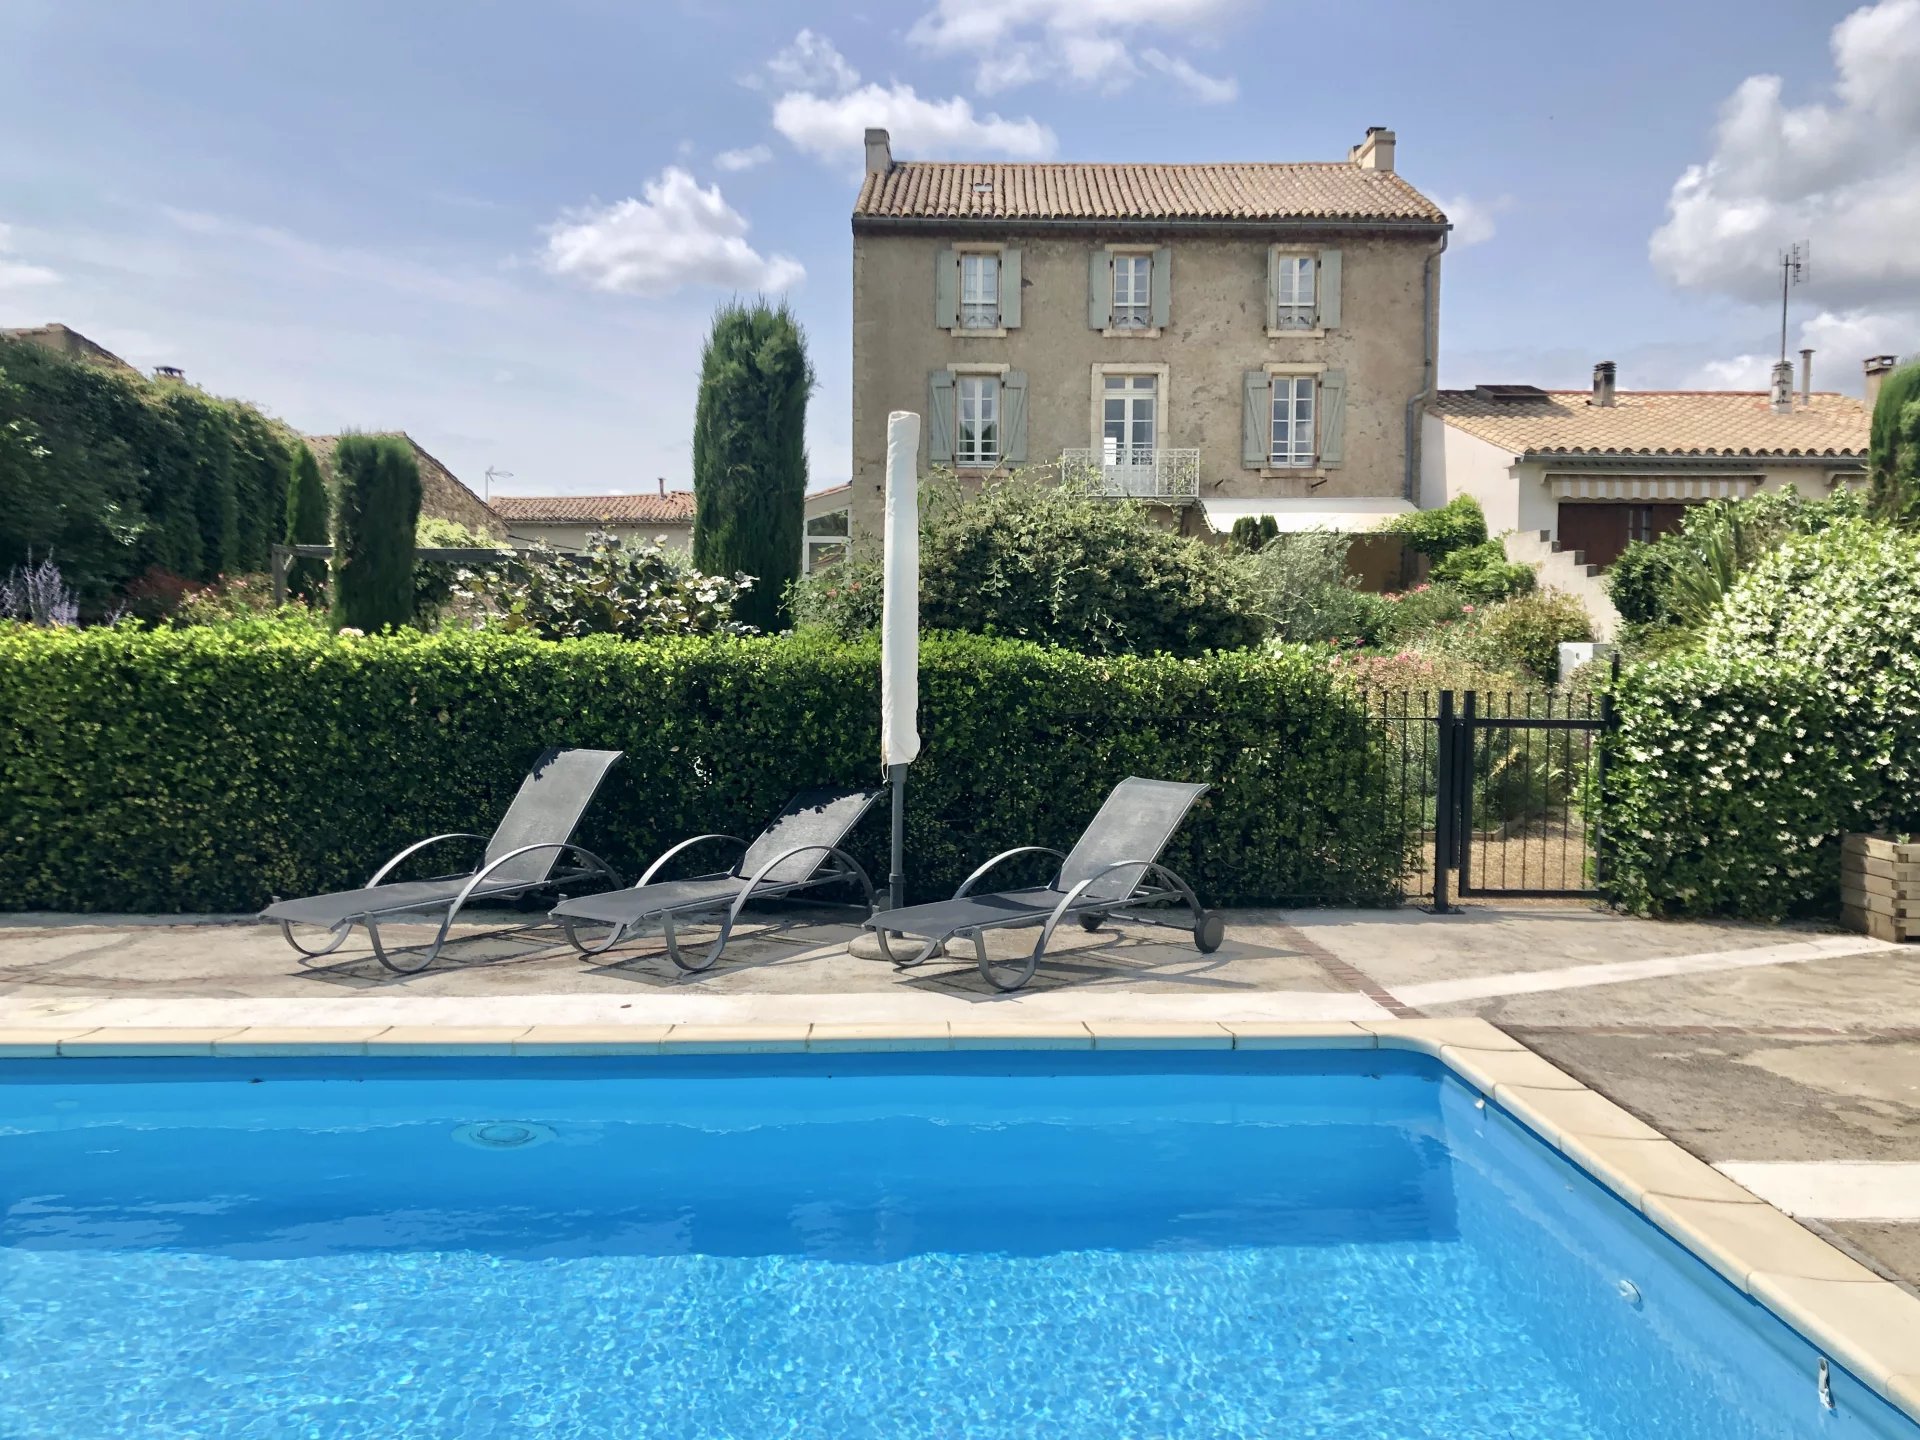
[{"xmin": 259, "ymin": 749, "xmax": 620, "ymax": 973}]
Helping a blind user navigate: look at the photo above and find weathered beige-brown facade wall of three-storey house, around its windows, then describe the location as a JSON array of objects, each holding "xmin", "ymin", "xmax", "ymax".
[{"xmin": 852, "ymin": 134, "xmax": 1446, "ymax": 541}]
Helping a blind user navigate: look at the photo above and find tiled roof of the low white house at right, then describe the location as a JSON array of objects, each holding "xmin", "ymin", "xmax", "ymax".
[{"xmin": 1432, "ymin": 390, "xmax": 1868, "ymax": 457}]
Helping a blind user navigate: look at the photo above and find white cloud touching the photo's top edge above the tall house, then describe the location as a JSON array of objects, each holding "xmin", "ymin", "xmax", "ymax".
[{"xmin": 906, "ymin": 0, "xmax": 1244, "ymax": 102}]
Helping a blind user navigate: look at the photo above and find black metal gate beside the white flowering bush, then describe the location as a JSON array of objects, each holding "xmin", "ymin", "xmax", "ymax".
[{"xmin": 1432, "ymin": 689, "xmax": 1613, "ymax": 912}]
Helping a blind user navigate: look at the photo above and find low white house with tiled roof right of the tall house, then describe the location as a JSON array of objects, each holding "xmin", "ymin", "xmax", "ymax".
[{"xmin": 1421, "ymin": 357, "xmax": 1866, "ymax": 632}]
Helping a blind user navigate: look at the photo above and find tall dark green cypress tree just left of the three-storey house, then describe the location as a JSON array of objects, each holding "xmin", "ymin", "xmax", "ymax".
[{"xmin": 693, "ymin": 300, "xmax": 814, "ymax": 630}]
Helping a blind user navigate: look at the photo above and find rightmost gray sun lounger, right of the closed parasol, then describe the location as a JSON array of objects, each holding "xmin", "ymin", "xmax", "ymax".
[{"xmin": 866, "ymin": 776, "xmax": 1223, "ymax": 991}]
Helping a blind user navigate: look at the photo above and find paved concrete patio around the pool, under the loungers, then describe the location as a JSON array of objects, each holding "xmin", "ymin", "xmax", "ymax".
[{"xmin": 0, "ymin": 906, "xmax": 1920, "ymax": 1290}]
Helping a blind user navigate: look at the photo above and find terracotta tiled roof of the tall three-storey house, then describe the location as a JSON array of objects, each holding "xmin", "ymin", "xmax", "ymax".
[{"xmin": 852, "ymin": 161, "xmax": 1446, "ymax": 225}]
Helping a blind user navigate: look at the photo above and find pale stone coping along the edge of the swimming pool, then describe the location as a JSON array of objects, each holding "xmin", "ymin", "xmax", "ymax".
[{"xmin": 0, "ymin": 1018, "xmax": 1920, "ymax": 1423}]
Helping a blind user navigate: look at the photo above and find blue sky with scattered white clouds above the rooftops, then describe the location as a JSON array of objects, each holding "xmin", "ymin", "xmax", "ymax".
[{"xmin": 0, "ymin": 0, "xmax": 1920, "ymax": 493}]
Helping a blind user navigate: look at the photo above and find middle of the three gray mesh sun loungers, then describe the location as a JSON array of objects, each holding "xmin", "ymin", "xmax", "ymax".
[{"xmin": 553, "ymin": 789, "xmax": 887, "ymax": 970}]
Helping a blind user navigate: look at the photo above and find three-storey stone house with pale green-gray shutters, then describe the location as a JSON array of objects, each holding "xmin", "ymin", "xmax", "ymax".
[{"xmin": 851, "ymin": 129, "xmax": 1448, "ymax": 541}]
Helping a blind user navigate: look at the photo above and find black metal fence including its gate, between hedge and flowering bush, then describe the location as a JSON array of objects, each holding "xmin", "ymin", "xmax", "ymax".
[{"xmin": 1365, "ymin": 689, "xmax": 1613, "ymax": 910}]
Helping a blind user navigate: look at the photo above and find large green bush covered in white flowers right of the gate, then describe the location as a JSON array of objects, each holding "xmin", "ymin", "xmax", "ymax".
[{"xmin": 1601, "ymin": 520, "xmax": 1920, "ymax": 918}]
